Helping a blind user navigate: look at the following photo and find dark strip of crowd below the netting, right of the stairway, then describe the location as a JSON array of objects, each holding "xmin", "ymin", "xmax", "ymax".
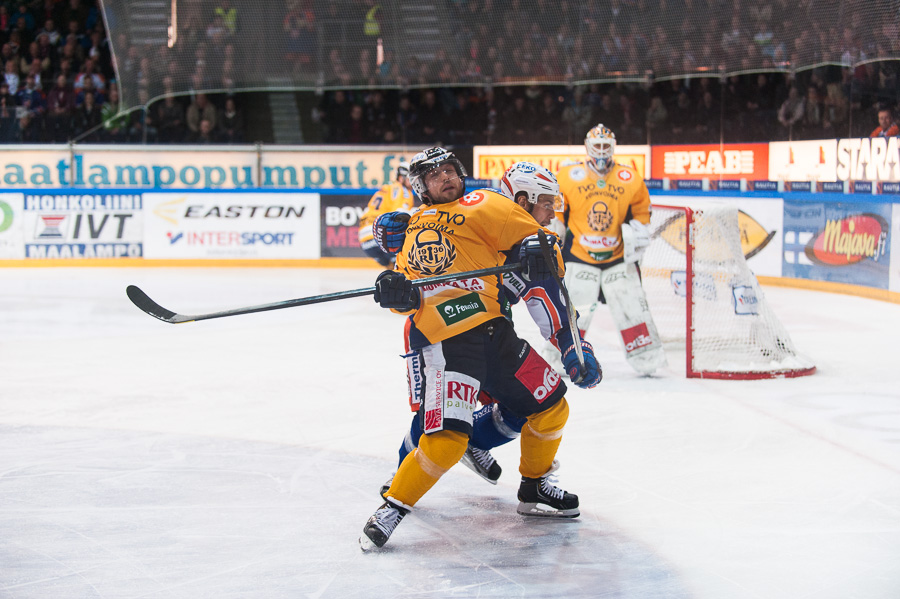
[{"xmin": 316, "ymin": 67, "xmax": 878, "ymax": 145}]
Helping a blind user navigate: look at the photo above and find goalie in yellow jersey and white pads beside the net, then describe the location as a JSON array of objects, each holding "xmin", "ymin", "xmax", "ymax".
[{"xmin": 545, "ymin": 124, "xmax": 666, "ymax": 374}]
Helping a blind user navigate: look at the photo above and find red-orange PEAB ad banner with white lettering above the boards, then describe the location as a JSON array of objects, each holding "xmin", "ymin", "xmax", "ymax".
[{"xmin": 650, "ymin": 143, "xmax": 769, "ymax": 181}]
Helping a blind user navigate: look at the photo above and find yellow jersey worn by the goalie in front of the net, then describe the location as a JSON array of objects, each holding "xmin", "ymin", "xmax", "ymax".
[{"xmin": 556, "ymin": 163, "xmax": 650, "ymax": 265}]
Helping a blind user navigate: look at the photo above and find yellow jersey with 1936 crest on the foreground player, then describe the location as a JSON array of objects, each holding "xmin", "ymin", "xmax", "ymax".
[{"xmin": 395, "ymin": 189, "xmax": 565, "ymax": 349}]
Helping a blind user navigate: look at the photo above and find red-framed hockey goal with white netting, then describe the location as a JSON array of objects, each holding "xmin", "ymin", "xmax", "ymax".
[{"xmin": 641, "ymin": 205, "xmax": 816, "ymax": 379}]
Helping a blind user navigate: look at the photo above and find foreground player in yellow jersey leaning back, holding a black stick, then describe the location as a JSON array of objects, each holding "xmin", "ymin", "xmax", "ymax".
[{"xmin": 360, "ymin": 148, "xmax": 580, "ymax": 550}]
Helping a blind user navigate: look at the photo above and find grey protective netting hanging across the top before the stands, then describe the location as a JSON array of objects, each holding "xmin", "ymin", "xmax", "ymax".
[{"xmin": 101, "ymin": 0, "xmax": 900, "ymax": 109}]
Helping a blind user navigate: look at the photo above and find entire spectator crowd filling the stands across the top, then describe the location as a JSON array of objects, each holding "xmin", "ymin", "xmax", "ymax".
[{"xmin": 0, "ymin": 0, "xmax": 900, "ymax": 145}]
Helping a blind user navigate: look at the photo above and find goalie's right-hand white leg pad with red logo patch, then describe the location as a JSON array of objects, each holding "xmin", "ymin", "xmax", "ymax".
[{"xmin": 600, "ymin": 263, "xmax": 667, "ymax": 374}]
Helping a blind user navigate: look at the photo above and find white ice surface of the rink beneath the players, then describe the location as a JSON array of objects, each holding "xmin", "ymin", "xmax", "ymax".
[{"xmin": 0, "ymin": 268, "xmax": 900, "ymax": 599}]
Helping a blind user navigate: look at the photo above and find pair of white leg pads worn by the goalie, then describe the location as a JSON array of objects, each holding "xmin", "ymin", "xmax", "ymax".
[{"xmin": 548, "ymin": 262, "xmax": 666, "ymax": 374}]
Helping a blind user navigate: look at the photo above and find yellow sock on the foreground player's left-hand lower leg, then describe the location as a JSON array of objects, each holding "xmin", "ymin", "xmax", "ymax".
[{"xmin": 385, "ymin": 431, "xmax": 469, "ymax": 506}]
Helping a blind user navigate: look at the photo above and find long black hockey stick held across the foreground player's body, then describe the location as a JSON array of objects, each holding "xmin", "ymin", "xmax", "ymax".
[{"xmin": 125, "ymin": 262, "xmax": 521, "ymax": 324}]
